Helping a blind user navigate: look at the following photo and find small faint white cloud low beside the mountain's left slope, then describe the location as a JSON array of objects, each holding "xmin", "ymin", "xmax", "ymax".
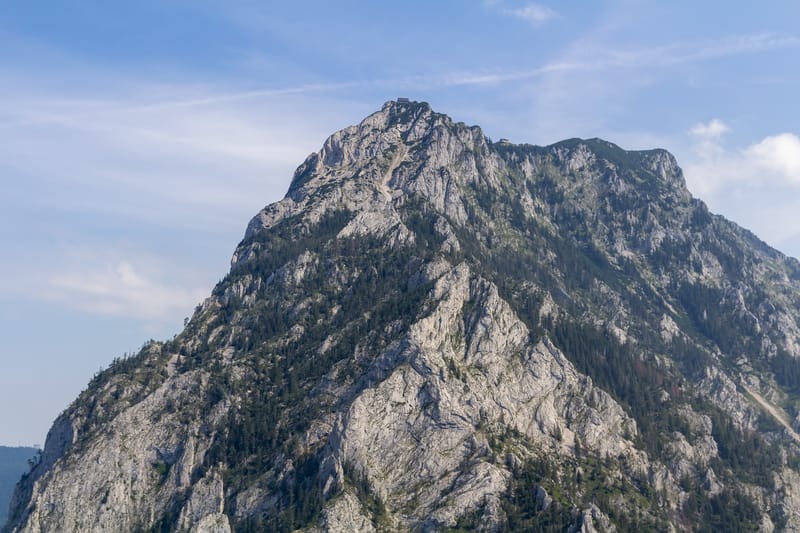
[{"xmin": 0, "ymin": 240, "xmax": 212, "ymax": 324}]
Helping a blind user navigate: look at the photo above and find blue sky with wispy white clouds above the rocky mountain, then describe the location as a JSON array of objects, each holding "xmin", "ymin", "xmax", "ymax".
[{"xmin": 0, "ymin": 0, "xmax": 800, "ymax": 445}]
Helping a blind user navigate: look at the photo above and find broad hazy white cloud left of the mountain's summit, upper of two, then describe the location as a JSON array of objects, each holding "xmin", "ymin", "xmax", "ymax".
[{"xmin": 0, "ymin": 84, "xmax": 340, "ymax": 219}]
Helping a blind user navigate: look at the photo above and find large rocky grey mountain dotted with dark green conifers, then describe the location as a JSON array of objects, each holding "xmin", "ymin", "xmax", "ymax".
[{"xmin": 9, "ymin": 101, "xmax": 800, "ymax": 533}]
